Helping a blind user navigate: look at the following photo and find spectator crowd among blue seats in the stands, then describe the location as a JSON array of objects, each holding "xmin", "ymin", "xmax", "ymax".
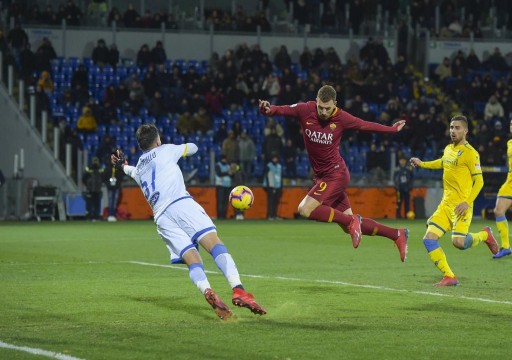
[{"xmin": 0, "ymin": 0, "xmax": 512, "ymax": 187}]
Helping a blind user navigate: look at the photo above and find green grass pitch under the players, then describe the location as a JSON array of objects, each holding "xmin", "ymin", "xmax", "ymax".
[{"xmin": 0, "ymin": 220, "xmax": 512, "ymax": 360}]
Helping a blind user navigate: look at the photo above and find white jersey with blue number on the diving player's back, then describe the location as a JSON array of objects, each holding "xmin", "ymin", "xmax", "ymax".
[{"xmin": 123, "ymin": 143, "xmax": 197, "ymax": 221}]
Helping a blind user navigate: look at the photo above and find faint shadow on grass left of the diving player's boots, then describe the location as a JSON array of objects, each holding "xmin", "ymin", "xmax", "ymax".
[{"xmin": 128, "ymin": 296, "xmax": 215, "ymax": 319}]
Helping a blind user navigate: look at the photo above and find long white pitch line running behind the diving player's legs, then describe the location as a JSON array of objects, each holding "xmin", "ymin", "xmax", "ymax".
[{"xmin": 126, "ymin": 261, "xmax": 512, "ymax": 305}]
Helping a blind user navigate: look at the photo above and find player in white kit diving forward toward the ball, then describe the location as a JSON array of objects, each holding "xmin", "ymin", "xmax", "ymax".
[{"xmin": 112, "ymin": 124, "xmax": 266, "ymax": 319}]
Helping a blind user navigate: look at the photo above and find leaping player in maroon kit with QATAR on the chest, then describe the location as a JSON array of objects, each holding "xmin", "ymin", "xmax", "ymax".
[{"xmin": 259, "ymin": 85, "xmax": 408, "ymax": 261}]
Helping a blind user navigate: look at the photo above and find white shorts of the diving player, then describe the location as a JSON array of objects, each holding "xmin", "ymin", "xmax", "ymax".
[{"xmin": 156, "ymin": 198, "xmax": 217, "ymax": 264}]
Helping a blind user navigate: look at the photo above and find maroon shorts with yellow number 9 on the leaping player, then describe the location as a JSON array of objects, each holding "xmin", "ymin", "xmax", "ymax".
[{"xmin": 308, "ymin": 170, "xmax": 350, "ymax": 212}]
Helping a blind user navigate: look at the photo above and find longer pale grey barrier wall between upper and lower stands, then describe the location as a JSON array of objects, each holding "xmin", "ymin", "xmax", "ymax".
[{"xmin": 26, "ymin": 28, "xmax": 396, "ymax": 62}]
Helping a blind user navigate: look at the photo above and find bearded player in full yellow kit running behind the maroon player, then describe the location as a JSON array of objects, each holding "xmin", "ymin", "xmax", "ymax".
[{"xmin": 410, "ymin": 115, "xmax": 498, "ymax": 286}]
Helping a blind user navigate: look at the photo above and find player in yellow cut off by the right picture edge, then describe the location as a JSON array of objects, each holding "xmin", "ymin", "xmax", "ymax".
[{"xmin": 493, "ymin": 121, "xmax": 512, "ymax": 259}]
